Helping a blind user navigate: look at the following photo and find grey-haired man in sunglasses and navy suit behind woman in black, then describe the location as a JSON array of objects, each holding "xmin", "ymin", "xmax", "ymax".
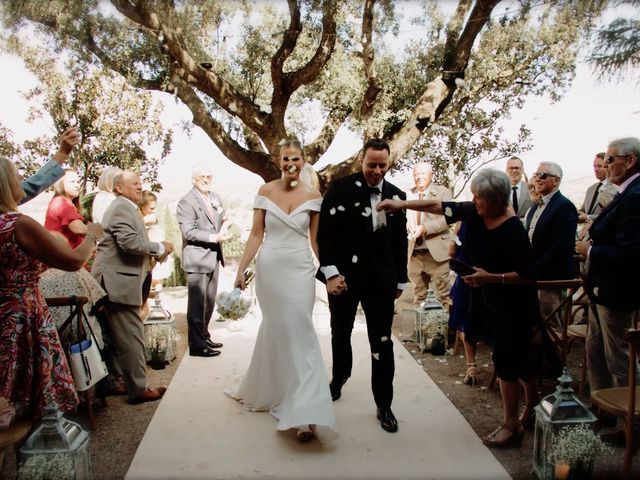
[{"xmin": 526, "ymin": 162, "xmax": 578, "ymax": 327}]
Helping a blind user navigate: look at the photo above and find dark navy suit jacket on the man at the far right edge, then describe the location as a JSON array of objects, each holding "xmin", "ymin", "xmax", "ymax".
[{"xmin": 587, "ymin": 177, "xmax": 640, "ymax": 310}]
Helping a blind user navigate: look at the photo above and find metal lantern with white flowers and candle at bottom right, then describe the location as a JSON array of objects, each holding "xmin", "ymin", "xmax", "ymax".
[{"xmin": 533, "ymin": 368, "xmax": 597, "ymax": 480}]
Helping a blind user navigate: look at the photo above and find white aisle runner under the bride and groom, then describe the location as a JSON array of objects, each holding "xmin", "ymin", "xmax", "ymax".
[{"xmin": 127, "ymin": 286, "xmax": 509, "ymax": 480}]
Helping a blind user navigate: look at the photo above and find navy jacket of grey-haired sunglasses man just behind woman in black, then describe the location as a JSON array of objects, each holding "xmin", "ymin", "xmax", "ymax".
[{"xmin": 526, "ymin": 191, "xmax": 578, "ymax": 280}]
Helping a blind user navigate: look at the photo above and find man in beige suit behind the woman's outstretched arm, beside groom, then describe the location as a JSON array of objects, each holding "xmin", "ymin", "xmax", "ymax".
[{"xmin": 407, "ymin": 162, "xmax": 452, "ymax": 308}]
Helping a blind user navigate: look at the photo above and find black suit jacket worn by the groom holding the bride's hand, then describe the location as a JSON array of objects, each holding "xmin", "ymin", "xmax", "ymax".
[{"xmin": 318, "ymin": 173, "xmax": 408, "ymax": 297}]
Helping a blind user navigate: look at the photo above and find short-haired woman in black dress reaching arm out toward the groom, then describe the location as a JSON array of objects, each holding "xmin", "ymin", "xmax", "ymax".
[{"xmin": 377, "ymin": 169, "xmax": 539, "ymax": 448}]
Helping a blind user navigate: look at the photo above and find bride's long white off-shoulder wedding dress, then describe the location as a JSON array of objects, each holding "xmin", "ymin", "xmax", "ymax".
[{"xmin": 225, "ymin": 195, "xmax": 337, "ymax": 441}]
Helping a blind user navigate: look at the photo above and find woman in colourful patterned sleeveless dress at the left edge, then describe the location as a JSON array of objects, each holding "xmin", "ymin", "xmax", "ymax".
[{"xmin": 0, "ymin": 158, "xmax": 102, "ymax": 420}]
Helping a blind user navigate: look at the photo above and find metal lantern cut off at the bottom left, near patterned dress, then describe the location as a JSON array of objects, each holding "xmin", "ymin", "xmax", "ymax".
[{"xmin": 18, "ymin": 406, "xmax": 91, "ymax": 480}]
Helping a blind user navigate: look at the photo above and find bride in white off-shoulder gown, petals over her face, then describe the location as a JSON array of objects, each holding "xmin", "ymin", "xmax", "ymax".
[{"xmin": 226, "ymin": 139, "xmax": 336, "ymax": 442}]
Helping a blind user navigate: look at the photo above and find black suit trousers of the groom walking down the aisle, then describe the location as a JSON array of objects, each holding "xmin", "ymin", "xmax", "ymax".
[{"xmin": 329, "ymin": 286, "xmax": 395, "ymax": 408}]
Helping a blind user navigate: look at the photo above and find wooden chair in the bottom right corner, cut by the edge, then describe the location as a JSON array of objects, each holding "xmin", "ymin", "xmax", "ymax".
[{"xmin": 591, "ymin": 329, "xmax": 640, "ymax": 479}]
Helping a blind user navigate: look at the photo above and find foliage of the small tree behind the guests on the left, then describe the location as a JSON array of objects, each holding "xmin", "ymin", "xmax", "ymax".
[{"xmin": 0, "ymin": 32, "xmax": 172, "ymax": 191}]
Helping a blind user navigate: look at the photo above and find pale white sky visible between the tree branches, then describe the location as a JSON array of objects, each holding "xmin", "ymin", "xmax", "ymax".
[{"xmin": 0, "ymin": 2, "xmax": 640, "ymax": 202}]
